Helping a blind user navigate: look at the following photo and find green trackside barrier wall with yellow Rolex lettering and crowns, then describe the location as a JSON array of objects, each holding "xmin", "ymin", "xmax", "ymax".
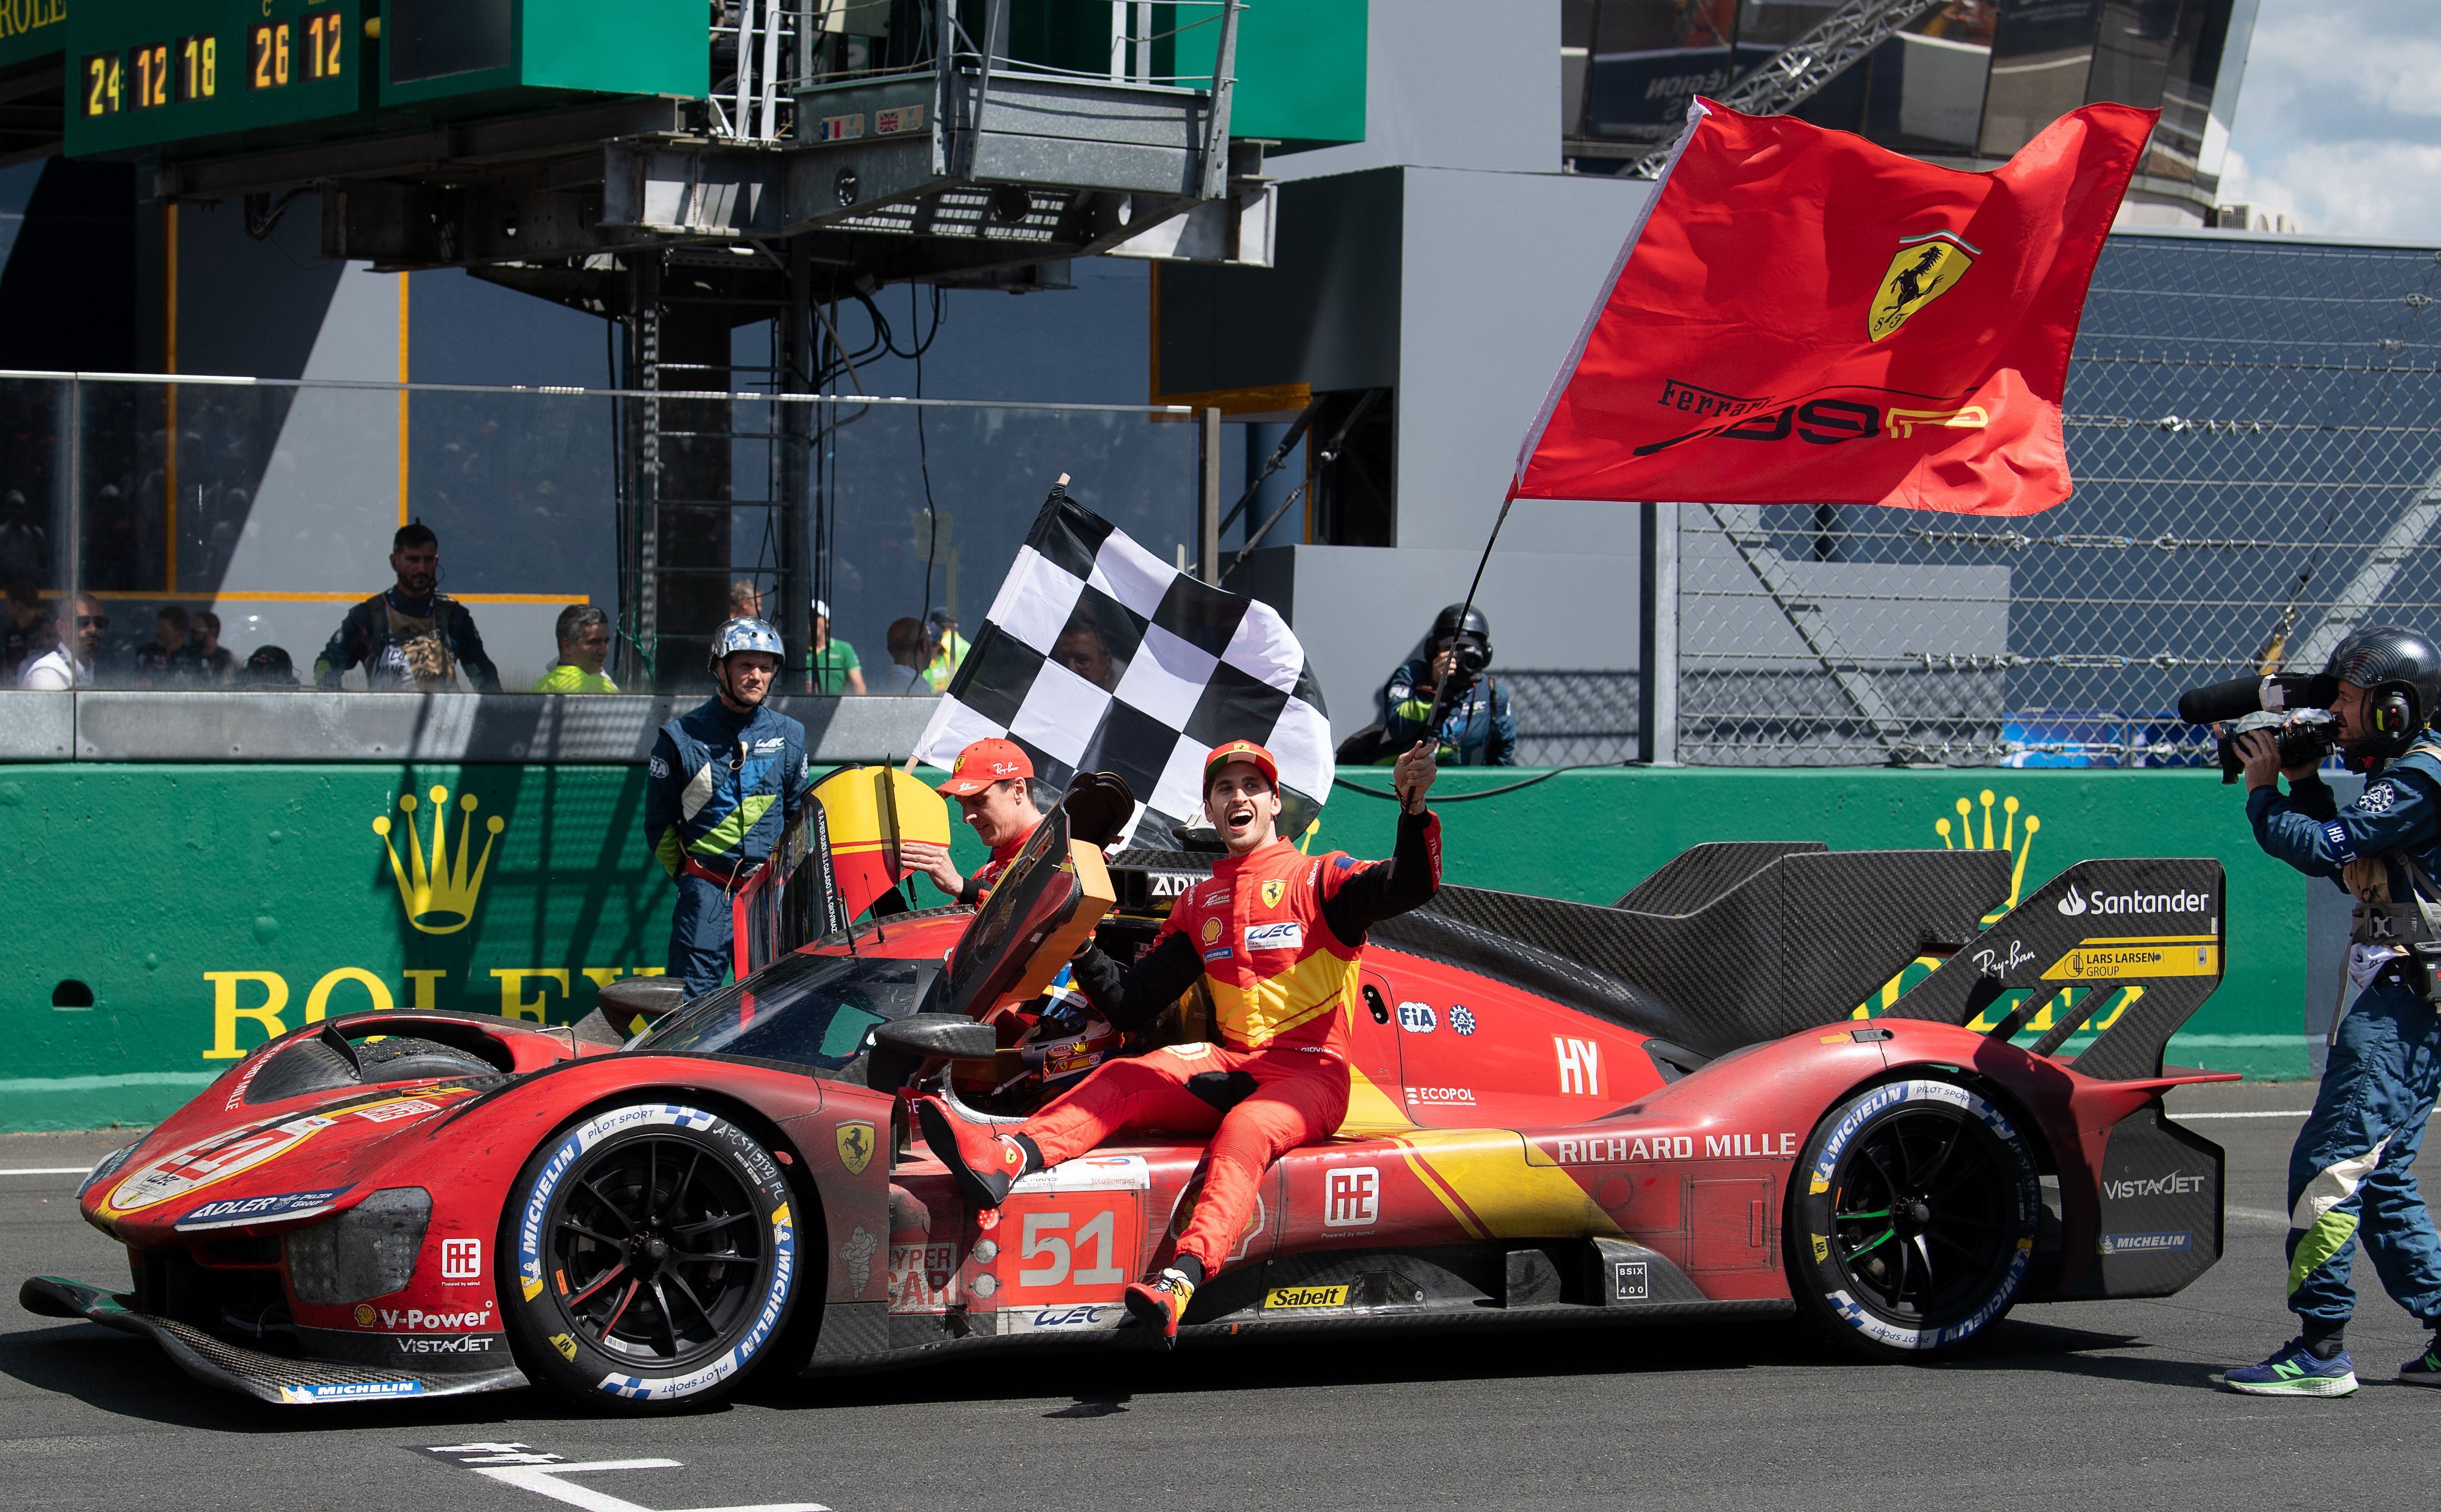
[{"xmin": 0, "ymin": 764, "xmax": 2307, "ymax": 1129}]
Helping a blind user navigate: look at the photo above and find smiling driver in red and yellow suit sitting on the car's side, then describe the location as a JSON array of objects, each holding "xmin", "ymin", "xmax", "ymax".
[{"xmin": 915, "ymin": 740, "xmax": 1440, "ymax": 1348}]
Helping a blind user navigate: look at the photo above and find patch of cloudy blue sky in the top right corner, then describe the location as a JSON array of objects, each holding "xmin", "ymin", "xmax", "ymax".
[{"xmin": 2221, "ymin": 0, "xmax": 2441, "ymax": 242}]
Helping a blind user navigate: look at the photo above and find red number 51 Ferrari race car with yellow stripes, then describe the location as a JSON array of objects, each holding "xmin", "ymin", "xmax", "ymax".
[{"xmin": 22, "ymin": 786, "xmax": 2224, "ymax": 1410}]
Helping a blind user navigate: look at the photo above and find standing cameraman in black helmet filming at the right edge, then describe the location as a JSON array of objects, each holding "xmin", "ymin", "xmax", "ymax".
[{"xmin": 2221, "ymin": 628, "xmax": 2441, "ymax": 1397}]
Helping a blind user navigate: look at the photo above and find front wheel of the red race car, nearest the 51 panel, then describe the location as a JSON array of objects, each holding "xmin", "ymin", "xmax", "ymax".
[{"xmin": 495, "ymin": 1102, "xmax": 803, "ymax": 1412}]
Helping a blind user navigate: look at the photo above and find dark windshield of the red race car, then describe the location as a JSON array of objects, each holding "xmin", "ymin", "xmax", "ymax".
[{"xmin": 634, "ymin": 955, "xmax": 940, "ymax": 1080}]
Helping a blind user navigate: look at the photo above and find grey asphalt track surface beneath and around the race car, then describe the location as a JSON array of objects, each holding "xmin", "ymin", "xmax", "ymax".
[{"xmin": 0, "ymin": 1085, "xmax": 2441, "ymax": 1512}]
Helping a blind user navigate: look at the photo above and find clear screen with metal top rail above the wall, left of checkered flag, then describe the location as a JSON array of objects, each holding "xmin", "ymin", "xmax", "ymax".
[{"xmin": 0, "ymin": 371, "xmax": 1206, "ymax": 696}]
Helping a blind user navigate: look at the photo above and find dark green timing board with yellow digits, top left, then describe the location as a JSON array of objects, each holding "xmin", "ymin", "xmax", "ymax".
[{"xmin": 64, "ymin": 0, "xmax": 373, "ymax": 154}]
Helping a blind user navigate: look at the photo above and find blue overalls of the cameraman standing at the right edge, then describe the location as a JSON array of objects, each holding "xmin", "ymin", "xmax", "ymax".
[{"xmin": 2246, "ymin": 735, "xmax": 2441, "ymax": 1334}]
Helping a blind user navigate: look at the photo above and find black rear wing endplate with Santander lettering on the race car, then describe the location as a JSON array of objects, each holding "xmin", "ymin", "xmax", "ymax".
[{"xmin": 1885, "ymin": 857, "xmax": 2229, "ymax": 1082}]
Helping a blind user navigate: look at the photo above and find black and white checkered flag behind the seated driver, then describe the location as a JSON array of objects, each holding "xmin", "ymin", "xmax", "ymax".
[{"xmin": 915, "ymin": 479, "xmax": 1333, "ymax": 845}]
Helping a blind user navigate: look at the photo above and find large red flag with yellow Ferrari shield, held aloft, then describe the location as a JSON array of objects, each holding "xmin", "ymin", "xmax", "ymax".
[{"xmin": 1509, "ymin": 100, "xmax": 2160, "ymax": 516}]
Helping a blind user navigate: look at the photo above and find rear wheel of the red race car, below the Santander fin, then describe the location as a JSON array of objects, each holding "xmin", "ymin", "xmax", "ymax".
[{"xmin": 1782, "ymin": 1077, "xmax": 2043, "ymax": 1361}]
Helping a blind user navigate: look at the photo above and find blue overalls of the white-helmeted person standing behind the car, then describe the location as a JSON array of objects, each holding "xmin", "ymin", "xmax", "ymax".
[{"xmin": 644, "ymin": 699, "xmax": 805, "ymax": 996}]
